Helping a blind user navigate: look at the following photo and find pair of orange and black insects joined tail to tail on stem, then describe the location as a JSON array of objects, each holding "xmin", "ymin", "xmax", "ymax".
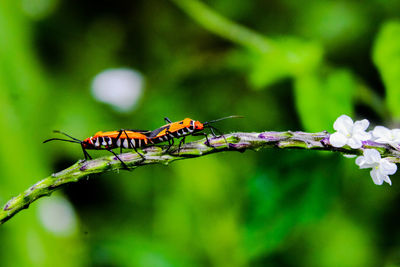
[{"xmin": 43, "ymin": 116, "xmax": 241, "ymax": 168}]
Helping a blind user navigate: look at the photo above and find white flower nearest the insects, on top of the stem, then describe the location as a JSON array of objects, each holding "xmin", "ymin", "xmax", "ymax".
[{"xmin": 329, "ymin": 115, "xmax": 371, "ymax": 149}]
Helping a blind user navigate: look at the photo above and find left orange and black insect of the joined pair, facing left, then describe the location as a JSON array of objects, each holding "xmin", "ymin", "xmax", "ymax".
[{"xmin": 43, "ymin": 129, "xmax": 152, "ymax": 168}]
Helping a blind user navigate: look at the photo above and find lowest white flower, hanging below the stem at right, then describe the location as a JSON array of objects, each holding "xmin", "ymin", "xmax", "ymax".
[{"xmin": 356, "ymin": 149, "xmax": 397, "ymax": 185}]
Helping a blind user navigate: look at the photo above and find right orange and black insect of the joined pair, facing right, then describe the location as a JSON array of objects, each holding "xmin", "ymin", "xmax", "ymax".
[{"xmin": 146, "ymin": 116, "xmax": 241, "ymax": 151}]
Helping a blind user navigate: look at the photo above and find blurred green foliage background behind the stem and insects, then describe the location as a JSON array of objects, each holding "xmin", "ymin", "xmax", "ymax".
[{"xmin": 0, "ymin": 0, "xmax": 400, "ymax": 266}]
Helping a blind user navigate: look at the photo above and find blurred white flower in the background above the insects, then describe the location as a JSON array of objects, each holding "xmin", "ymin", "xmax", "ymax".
[{"xmin": 92, "ymin": 69, "xmax": 144, "ymax": 112}]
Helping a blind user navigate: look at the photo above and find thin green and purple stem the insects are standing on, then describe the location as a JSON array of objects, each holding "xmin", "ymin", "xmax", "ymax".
[{"xmin": 0, "ymin": 131, "xmax": 400, "ymax": 224}]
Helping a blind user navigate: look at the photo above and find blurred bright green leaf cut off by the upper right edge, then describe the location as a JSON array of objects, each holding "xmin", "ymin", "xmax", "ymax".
[{"xmin": 373, "ymin": 21, "xmax": 400, "ymax": 119}]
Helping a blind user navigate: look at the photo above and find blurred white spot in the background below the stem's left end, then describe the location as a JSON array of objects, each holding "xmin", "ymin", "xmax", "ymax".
[{"xmin": 38, "ymin": 196, "xmax": 77, "ymax": 236}]
